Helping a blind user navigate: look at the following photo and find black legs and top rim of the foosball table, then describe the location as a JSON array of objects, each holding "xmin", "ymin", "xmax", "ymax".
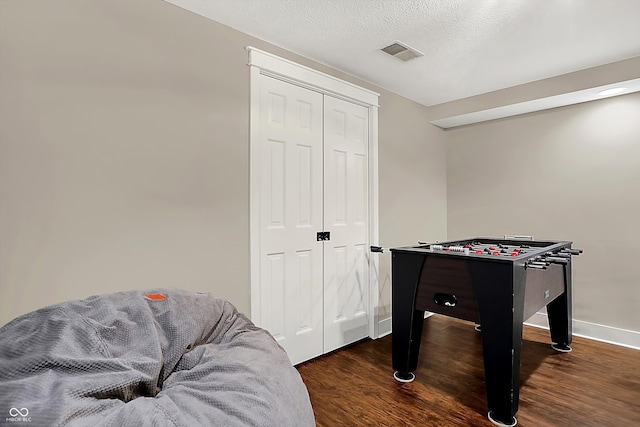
[{"xmin": 391, "ymin": 238, "xmax": 572, "ymax": 425}]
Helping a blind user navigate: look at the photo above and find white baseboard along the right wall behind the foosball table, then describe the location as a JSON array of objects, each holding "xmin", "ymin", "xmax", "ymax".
[{"xmin": 524, "ymin": 312, "xmax": 640, "ymax": 350}]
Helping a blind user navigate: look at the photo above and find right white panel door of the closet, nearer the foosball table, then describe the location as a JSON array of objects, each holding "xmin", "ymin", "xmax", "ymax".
[{"xmin": 324, "ymin": 95, "xmax": 369, "ymax": 353}]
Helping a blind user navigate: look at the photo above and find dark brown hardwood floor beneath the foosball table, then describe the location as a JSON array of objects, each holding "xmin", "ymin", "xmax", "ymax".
[{"xmin": 297, "ymin": 315, "xmax": 640, "ymax": 427}]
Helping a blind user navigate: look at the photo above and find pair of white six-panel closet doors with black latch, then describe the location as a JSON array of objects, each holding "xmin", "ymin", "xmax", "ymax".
[{"xmin": 252, "ymin": 75, "xmax": 369, "ymax": 364}]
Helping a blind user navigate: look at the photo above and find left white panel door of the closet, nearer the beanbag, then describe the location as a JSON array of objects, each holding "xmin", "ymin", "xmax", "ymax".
[{"xmin": 254, "ymin": 75, "xmax": 323, "ymax": 364}]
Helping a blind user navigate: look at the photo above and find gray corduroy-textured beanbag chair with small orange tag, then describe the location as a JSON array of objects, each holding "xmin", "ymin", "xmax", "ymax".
[{"xmin": 0, "ymin": 290, "xmax": 315, "ymax": 427}]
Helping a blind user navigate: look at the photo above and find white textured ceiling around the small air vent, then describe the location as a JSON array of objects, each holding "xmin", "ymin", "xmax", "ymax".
[{"xmin": 167, "ymin": 0, "xmax": 640, "ymax": 106}]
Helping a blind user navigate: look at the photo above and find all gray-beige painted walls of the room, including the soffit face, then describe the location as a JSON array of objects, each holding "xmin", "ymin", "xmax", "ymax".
[{"xmin": 6, "ymin": 0, "xmax": 640, "ymax": 338}]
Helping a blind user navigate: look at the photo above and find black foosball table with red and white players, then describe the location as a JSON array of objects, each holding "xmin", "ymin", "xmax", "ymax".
[{"xmin": 372, "ymin": 236, "xmax": 582, "ymax": 426}]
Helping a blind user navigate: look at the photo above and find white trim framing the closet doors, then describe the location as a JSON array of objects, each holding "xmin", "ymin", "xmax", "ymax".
[{"xmin": 246, "ymin": 46, "xmax": 380, "ymax": 339}]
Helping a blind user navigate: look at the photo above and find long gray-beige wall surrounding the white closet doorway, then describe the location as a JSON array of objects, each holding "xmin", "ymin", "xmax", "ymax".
[{"xmin": 0, "ymin": 0, "xmax": 446, "ymax": 325}]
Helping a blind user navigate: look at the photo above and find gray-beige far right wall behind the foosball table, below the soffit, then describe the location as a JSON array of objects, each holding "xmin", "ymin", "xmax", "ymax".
[{"xmin": 444, "ymin": 93, "xmax": 640, "ymax": 331}]
